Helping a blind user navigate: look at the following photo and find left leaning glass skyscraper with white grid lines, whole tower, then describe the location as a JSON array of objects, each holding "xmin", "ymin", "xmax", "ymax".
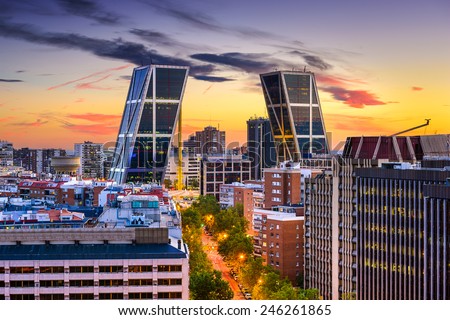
[{"xmin": 109, "ymin": 65, "xmax": 189, "ymax": 183}]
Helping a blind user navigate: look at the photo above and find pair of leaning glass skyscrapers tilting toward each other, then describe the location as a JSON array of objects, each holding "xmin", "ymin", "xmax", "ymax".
[{"xmin": 109, "ymin": 65, "xmax": 329, "ymax": 184}]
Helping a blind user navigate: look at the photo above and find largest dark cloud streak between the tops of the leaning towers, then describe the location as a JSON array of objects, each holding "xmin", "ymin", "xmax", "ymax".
[{"xmin": 191, "ymin": 52, "xmax": 274, "ymax": 73}]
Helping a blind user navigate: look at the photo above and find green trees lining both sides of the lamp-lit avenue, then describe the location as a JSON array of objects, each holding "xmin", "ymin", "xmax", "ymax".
[{"xmin": 182, "ymin": 196, "xmax": 320, "ymax": 300}]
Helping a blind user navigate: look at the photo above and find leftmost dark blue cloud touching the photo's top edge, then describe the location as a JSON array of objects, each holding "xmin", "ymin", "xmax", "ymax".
[{"xmin": 57, "ymin": 0, "xmax": 121, "ymax": 25}]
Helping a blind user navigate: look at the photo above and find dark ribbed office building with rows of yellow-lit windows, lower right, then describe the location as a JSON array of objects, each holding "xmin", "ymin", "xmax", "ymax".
[{"xmin": 356, "ymin": 163, "xmax": 450, "ymax": 300}]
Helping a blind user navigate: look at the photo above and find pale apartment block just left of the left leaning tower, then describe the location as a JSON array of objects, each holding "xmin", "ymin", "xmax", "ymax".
[{"xmin": 74, "ymin": 141, "xmax": 105, "ymax": 179}]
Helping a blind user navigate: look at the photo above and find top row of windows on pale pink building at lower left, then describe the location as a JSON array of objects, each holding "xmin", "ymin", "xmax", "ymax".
[{"xmin": 0, "ymin": 265, "xmax": 182, "ymax": 274}]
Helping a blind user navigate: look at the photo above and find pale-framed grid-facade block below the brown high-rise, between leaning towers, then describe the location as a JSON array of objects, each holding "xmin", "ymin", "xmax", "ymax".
[{"xmin": 200, "ymin": 155, "xmax": 251, "ymax": 200}]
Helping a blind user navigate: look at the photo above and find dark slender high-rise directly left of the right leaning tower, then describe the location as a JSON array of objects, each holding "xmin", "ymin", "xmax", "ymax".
[{"xmin": 247, "ymin": 118, "xmax": 277, "ymax": 180}]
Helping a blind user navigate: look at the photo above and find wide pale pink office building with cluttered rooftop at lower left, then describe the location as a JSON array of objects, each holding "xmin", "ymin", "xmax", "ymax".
[{"xmin": 0, "ymin": 194, "xmax": 189, "ymax": 300}]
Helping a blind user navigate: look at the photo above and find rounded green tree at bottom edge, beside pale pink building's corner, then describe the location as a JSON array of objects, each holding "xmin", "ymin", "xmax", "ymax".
[{"xmin": 189, "ymin": 270, "xmax": 233, "ymax": 300}]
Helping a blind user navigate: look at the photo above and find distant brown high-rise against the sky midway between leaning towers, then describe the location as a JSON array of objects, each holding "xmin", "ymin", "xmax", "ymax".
[{"xmin": 195, "ymin": 126, "xmax": 226, "ymax": 155}]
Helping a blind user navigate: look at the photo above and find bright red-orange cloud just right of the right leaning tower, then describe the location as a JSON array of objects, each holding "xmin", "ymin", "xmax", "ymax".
[{"xmin": 322, "ymin": 87, "xmax": 388, "ymax": 109}]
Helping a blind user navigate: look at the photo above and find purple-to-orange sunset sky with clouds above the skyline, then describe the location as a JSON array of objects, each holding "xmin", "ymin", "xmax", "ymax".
[{"xmin": 0, "ymin": 0, "xmax": 450, "ymax": 149}]
